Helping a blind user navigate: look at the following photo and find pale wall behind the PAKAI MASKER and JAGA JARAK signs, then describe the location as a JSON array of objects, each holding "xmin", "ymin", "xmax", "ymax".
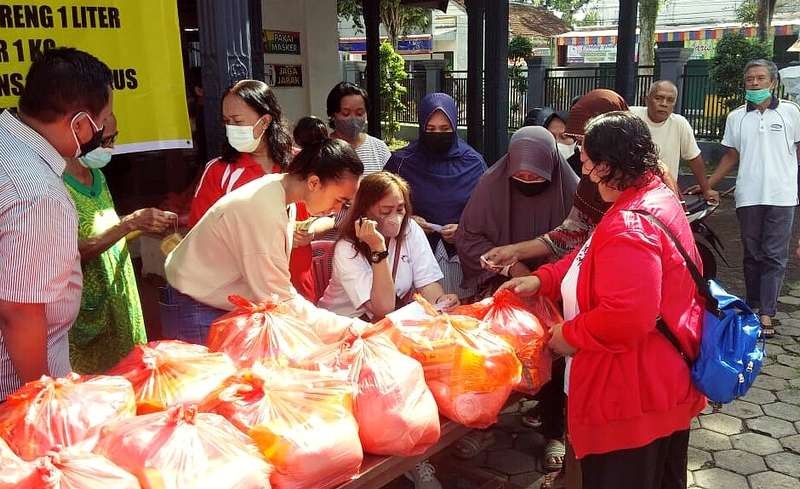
[{"xmin": 262, "ymin": 0, "xmax": 342, "ymax": 124}]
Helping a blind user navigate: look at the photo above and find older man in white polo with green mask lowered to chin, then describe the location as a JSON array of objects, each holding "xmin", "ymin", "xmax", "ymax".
[{"xmin": 709, "ymin": 59, "xmax": 800, "ymax": 337}]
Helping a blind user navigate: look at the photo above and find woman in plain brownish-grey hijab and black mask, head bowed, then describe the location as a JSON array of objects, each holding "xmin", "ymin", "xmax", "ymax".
[{"xmin": 455, "ymin": 127, "xmax": 578, "ymax": 293}]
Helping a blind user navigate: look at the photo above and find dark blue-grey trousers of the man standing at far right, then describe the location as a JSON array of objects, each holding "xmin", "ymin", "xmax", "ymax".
[{"xmin": 736, "ymin": 205, "xmax": 796, "ymax": 316}]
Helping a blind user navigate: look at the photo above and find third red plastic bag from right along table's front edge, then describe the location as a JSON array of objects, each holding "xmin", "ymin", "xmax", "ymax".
[{"xmin": 311, "ymin": 329, "xmax": 440, "ymax": 457}]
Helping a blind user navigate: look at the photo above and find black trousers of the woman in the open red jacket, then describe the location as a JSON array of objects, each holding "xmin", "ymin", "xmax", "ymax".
[{"xmin": 581, "ymin": 430, "xmax": 689, "ymax": 489}]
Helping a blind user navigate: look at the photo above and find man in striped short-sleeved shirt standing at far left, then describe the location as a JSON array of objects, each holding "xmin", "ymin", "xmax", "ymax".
[{"xmin": 0, "ymin": 48, "xmax": 113, "ymax": 402}]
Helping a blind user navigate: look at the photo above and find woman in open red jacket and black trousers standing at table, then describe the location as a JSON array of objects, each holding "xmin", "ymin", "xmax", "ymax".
[{"xmin": 503, "ymin": 112, "xmax": 705, "ymax": 489}]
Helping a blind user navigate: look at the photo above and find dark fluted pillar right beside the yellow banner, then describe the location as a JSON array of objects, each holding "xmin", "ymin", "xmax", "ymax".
[{"xmin": 197, "ymin": 0, "xmax": 264, "ymax": 154}]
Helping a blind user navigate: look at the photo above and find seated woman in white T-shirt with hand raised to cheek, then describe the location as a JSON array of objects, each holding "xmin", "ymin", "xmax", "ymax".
[{"xmin": 319, "ymin": 172, "xmax": 458, "ymax": 321}]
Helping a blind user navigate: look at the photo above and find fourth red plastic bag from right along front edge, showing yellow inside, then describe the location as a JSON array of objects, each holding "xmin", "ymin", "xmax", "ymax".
[{"xmin": 200, "ymin": 364, "xmax": 364, "ymax": 489}]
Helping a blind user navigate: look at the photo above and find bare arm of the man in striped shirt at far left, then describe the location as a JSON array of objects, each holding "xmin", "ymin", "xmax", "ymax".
[{"xmin": 0, "ymin": 300, "xmax": 50, "ymax": 383}]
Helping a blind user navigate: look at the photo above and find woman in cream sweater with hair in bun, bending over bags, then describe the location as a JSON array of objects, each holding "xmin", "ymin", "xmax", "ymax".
[{"xmin": 161, "ymin": 135, "xmax": 364, "ymax": 343}]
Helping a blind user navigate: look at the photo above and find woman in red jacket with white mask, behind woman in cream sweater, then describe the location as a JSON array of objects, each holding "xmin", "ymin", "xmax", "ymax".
[{"xmin": 189, "ymin": 80, "xmax": 332, "ymax": 302}]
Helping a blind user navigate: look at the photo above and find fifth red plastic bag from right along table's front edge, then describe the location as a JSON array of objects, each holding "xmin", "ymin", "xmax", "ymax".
[{"xmin": 95, "ymin": 406, "xmax": 272, "ymax": 489}]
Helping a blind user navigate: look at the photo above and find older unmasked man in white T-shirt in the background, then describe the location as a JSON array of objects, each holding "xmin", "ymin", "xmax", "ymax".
[{"xmin": 630, "ymin": 80, "xmax": 719, "ymax": 203}]
